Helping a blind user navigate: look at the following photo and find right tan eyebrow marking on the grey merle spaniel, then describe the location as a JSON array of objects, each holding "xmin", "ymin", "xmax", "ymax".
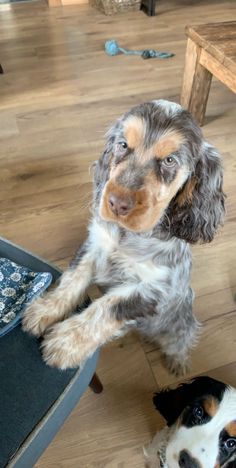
[{"xmin": 154, "ymin": 130, "xmax": 185, "ymax": 159}]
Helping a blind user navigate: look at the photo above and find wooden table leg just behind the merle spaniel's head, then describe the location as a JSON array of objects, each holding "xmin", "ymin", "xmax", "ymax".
[{"xmin": 180, "ymin": 39, "xmax": 212, "ymax": 125}]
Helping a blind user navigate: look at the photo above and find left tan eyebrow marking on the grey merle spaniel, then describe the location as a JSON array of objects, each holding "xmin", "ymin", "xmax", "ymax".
[{"xmin": 124, "ymin": 115, "xmax": 145, "ymax": 149}]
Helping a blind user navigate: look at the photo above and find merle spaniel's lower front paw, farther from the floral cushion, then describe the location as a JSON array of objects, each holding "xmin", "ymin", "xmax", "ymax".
[{"xmin": 42, "ymin": 319, "xmax": 87, "ymax": 370}]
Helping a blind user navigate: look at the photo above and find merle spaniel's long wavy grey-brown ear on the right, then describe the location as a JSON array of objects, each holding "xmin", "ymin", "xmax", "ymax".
[{"xmin": 168, "ymin": 142, "xmax": 225, "ymax": 243}]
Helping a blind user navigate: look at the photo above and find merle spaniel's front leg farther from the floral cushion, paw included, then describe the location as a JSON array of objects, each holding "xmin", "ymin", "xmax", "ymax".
[{"xmin": 42, "ymin": 287, "xmax": 135, "ymax": 369}]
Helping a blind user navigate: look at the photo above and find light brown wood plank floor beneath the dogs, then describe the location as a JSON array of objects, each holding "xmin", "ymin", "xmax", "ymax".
[{"xmin": 0, "ymin": 0, "xmax": 236, "ymax": 468}]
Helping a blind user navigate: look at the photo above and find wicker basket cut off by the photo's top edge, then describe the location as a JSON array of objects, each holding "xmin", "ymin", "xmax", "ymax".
[{"xmin": 89, "ymin": 0, "xmax": 141, "ymax": 15}]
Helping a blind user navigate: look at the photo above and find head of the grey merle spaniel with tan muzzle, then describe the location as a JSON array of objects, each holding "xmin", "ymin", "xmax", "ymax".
[{"xmin": 95, "ymin": 100, "xmax": 224, "ymax": 243}]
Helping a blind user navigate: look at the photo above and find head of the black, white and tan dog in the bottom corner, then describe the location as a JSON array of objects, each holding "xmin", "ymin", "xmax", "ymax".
[{"xmin": 148, "ymin": 377, "xmax": 236, "ymax": 468}]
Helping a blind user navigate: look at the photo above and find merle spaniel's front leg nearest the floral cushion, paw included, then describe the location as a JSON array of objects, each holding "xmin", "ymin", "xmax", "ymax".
[{"xmin": 22, "ymin": 253, "xmax": 93, "ymax": 336}]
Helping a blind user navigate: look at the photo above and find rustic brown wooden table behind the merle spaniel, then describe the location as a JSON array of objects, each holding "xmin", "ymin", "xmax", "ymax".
[{"xmin": 181, "ymin": 21, "xmax": 236, "ymax": 125}]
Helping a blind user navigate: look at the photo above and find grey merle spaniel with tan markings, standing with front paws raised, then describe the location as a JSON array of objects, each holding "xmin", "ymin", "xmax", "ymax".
[{"xmin": 23, "ymin": 100, "xmax": 224, "ymax": 374}]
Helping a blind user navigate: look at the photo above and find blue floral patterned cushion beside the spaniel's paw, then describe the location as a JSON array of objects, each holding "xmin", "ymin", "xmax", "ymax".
[{"xmin": 0, "ymin": 258, "xmax": 52, "ymax": 337}]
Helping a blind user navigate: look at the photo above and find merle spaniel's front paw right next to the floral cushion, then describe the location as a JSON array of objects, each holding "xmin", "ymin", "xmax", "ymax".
[{"xmin": 22, "ymin": 297, "xmax": 59, "ymax": 337}]
